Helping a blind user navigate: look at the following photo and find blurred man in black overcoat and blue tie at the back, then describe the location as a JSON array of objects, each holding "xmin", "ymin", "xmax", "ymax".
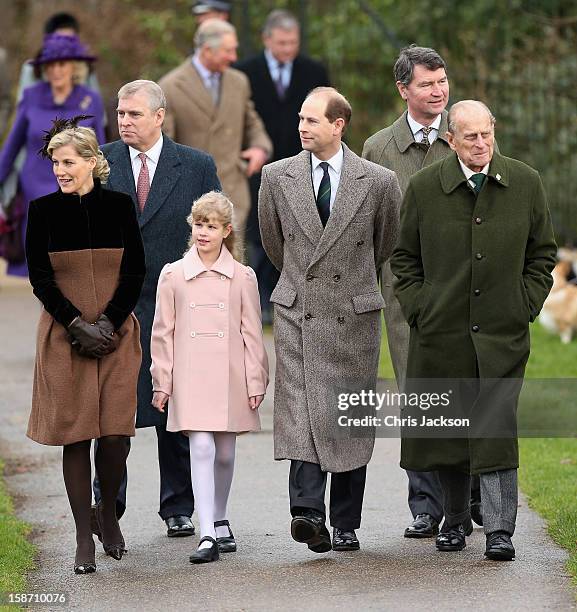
[{"xmin": 236, "ymin": 10, "xmax": 329, "ymax": 322}]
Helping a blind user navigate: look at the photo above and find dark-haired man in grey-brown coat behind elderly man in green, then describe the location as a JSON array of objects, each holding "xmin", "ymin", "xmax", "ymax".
[{"xmin": 363, "ymin": 45, "xmax": 452, "ymax": 538}]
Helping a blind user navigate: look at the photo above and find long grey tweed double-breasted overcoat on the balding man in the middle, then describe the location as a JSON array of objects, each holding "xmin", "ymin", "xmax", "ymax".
[{"xmin": 259, "ymin": 145, "xmax": 401, "ymax": 472}]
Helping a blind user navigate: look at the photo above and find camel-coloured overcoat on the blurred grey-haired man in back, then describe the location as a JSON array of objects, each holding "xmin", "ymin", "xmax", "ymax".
[{"xmin": 159, "ymin": 58, "xmax": 272, "ymax": 230}]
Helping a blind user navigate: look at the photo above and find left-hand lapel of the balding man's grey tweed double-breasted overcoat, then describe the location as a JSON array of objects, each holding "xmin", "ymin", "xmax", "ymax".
[{"xmin": 278, "ymin": 151, "xmax": 323, "ymax": 244}]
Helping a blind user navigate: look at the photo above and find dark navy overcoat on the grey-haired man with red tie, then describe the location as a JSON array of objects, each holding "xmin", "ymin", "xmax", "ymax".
[{"xmin": 102, "ymin": 135, "xmax": 220, "ymax": 427}]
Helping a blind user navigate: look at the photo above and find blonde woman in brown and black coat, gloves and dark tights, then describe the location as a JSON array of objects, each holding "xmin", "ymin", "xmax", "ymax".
[{"xmin": 26, "ymin": 120, "xmax": 145, "ymax": 574}]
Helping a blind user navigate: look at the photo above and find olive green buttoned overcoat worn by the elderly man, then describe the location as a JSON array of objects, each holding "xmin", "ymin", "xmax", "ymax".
[{"xmin": 391, "ymin": 153, "xmax": 556, "ymax": 473}]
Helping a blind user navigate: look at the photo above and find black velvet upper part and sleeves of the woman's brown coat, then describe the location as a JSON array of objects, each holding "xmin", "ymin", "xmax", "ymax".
[{"xmin": 26, "ymin": 179, "xmax": 146, "ymax": 329}]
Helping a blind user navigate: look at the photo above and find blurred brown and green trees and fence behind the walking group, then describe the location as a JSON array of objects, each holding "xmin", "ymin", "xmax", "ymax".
[{"xmin": 0, "ymin": 0, "xmax": 577, "ymax": 243}]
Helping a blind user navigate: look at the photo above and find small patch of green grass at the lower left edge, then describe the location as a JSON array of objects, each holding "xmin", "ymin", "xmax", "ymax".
[{"xmin": 0, "ymin": 461, "xmax": 35, "ymax": 610}]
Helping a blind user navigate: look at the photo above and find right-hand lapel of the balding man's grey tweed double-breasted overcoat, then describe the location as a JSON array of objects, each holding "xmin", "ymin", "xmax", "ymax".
[{"xmin": 311, "ymin": 144, "xmax": 371, "ymax": 263}]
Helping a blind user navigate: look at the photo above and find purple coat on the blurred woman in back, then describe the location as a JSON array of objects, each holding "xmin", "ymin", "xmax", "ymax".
[{"xmin": 0, "ymin": 82, "xmax": 104, "ymax": 276}]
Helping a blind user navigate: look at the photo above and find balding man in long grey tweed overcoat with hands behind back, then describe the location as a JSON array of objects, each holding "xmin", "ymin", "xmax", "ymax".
[{"xmin": 259, "ymin": 87, "xmax": 401, "ymax": 552}]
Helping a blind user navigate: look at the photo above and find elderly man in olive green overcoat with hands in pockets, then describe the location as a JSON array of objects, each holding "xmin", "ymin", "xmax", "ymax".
[{"xmin": 391, "ymin": 100, "xmax": 556, "ymax": 560}]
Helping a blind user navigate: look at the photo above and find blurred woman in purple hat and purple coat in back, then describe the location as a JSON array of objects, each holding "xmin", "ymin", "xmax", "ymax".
[{"xmin": 0, "ymin": 34, "xmax": 104, "ymax": 276}]
